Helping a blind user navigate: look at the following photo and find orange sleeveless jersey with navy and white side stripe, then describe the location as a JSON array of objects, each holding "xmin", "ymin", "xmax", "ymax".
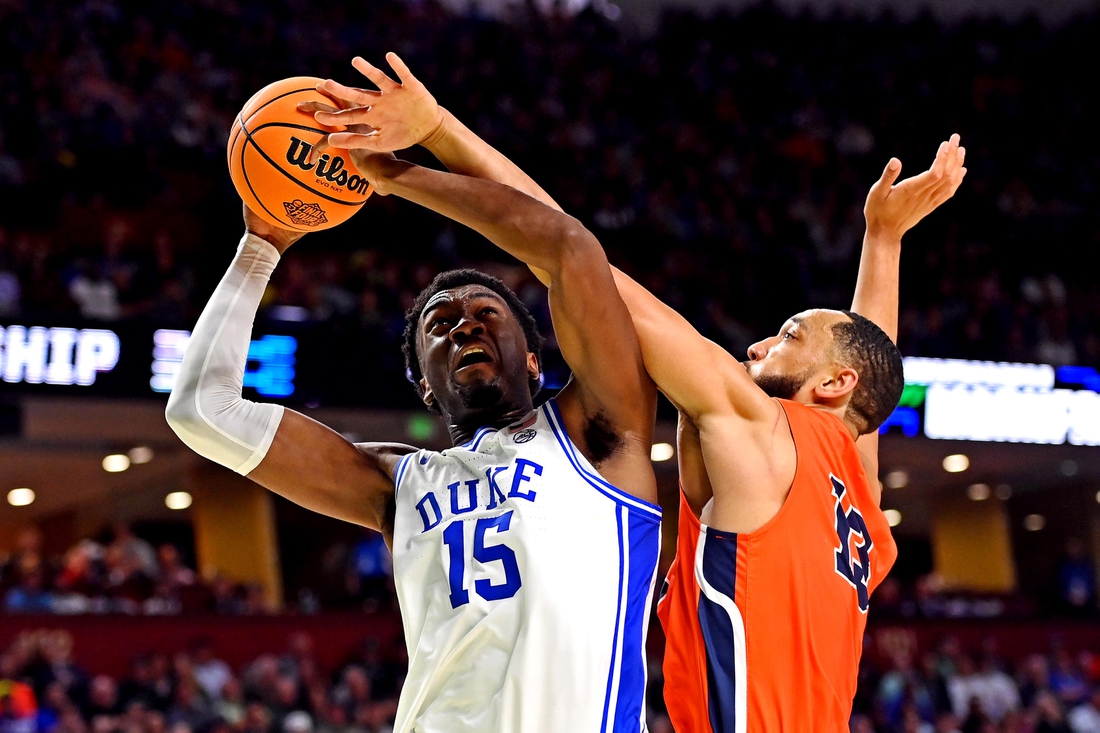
[{"xmin": 657, "ymin": 400, "xmax": 898, "ymax": 733}]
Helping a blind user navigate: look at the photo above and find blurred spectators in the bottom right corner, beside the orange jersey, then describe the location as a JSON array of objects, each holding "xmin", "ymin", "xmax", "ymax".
[{"xmin": 851, "ymin": 636, "xmax": 1100, "ymax": 733}]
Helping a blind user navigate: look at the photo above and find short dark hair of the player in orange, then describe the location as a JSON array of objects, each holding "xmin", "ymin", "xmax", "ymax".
[{"xmin": 833, "ymin": 310, "xmax": 905, "ymax": 435}]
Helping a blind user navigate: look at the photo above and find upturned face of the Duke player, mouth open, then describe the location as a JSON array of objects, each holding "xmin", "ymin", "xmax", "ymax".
[{"xmin": 419, "ymin": 285, "xmax": 538, "ymax": 422}]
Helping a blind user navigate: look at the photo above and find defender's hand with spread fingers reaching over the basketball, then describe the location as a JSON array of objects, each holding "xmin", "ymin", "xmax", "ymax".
[{"xmin": 301, "ymin": 53, "xmax": 444, "ymax": 153}]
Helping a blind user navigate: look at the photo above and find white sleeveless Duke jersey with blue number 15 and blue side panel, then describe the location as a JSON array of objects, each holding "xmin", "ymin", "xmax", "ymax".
[{"xmin": 394, "ymin": 401, "xmax": 661, "ymax": 733}]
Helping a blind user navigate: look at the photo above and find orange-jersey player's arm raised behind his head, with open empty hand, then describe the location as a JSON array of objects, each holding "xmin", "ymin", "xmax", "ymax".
[{"xmin": 851, "ymin": 134, "xmax": 966, "ymax": 477}]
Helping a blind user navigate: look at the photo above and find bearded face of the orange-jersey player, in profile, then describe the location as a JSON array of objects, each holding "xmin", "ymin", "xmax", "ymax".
[{"xmin": 745, "ymin": 309, "xmax": 848, "ymax": 400}]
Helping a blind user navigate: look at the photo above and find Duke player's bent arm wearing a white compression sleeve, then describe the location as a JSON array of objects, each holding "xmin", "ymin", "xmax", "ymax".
[{"xmin": 165, "ymin": 202, "xmax": 411, "ymax": 536}]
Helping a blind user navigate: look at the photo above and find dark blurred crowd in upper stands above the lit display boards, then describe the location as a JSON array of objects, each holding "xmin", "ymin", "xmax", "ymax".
[{"xmin": 0, "ymin": 0, "xmax": 1100, "ymax": 387}]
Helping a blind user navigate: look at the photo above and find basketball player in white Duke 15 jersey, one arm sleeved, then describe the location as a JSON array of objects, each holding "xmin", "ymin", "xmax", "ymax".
[{"xmin": 166, "ymin": 118, "xmax": 661, "ymax": 733}]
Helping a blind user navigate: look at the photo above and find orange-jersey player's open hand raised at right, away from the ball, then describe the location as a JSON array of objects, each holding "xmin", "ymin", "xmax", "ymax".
[{"xmin": 864, "ymin": 134, "xmax": 966, "ymax": 241}]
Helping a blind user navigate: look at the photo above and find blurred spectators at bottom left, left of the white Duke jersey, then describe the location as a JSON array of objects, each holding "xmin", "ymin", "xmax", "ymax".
[{"xmin": 0, "ymin": 631, "xmax": 404, "ymax": 733}]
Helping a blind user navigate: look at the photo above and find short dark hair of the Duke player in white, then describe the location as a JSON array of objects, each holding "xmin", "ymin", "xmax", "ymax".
[{"xmin": 402, "ymin": 267, "xmax": 546, "ymax": 405}]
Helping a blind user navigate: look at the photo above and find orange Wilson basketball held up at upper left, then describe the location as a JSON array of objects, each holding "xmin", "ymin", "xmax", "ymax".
[{"xmin": 228, "ymin": 76, "xmax": 374, "ymax": 231}]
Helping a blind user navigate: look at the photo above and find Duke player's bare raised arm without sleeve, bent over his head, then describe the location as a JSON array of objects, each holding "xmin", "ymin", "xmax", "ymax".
[{"xmin": 355, "ymin": 153, "xmax": 657, "ymax": 494}]
